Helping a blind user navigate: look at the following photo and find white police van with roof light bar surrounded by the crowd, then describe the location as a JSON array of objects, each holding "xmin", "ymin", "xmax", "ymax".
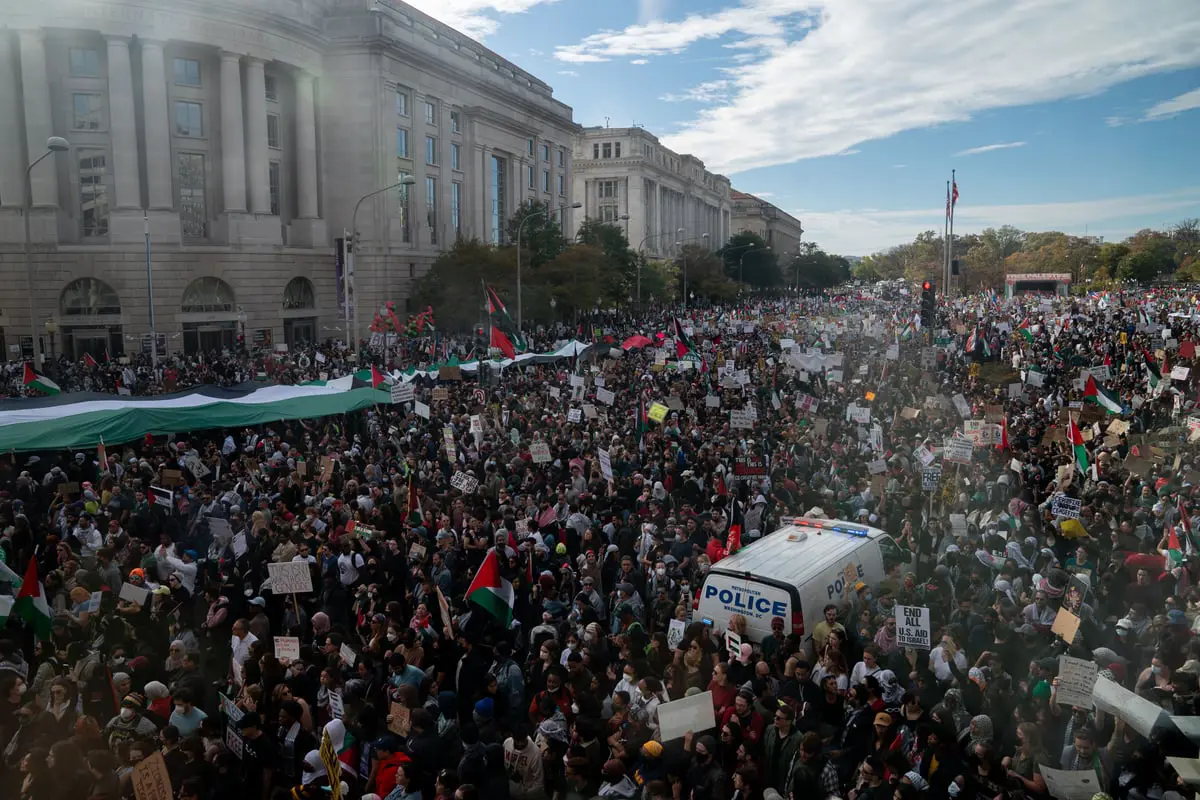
[{"xmin": 696, "ymin": 517, "xmax": 902, "ymax": 642}]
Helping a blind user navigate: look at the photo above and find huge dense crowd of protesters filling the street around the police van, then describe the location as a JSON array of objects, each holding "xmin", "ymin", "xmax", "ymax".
[{"xmin": 0, "ymin": 290, "xmax": 1200, "ymax": 800}]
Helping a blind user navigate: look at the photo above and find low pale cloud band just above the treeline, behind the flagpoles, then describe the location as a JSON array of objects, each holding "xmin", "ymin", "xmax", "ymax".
[{"xmin": 787, "ymin": 187, "xmax": 1200, "ymax": 255}]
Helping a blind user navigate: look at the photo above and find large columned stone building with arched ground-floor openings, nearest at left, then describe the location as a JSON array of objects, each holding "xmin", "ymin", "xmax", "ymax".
[{"xmin": 0, "ymin": 0, "xmax": 577, "ymax": 359}]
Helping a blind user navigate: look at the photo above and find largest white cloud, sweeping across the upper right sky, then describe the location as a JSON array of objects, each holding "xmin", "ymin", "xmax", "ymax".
[{"xmin": 556, "ymin": 0, "xmax": 1200, "ymax": 174}]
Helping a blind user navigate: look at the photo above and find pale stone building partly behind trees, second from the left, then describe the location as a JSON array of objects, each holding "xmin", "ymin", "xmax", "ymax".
[{"xmin": 571, "ymin": 127, "xmax": 730, "ymax": 258}]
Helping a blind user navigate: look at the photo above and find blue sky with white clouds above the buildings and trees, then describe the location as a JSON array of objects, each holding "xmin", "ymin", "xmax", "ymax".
[{"xmin": 410, "ymin": 0, "xmax": 1200, "ymax": 255}]
